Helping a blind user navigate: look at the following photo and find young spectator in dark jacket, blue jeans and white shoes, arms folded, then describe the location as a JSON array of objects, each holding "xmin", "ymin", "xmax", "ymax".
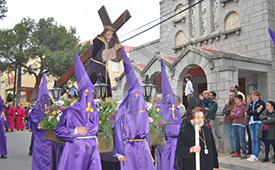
[{"xmin": 247, "ymin": 90, "xmax": 265, "ymax": 162}]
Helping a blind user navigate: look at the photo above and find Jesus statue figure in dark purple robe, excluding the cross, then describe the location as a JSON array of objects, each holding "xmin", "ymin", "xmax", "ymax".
[{"xmin": 87, "ymin": 25, "xmax": 121, "ymax": 97}]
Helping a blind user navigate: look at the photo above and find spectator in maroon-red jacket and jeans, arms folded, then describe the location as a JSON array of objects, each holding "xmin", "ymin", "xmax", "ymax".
[{"xmin": 230, "ymin": 94, "xmax": 247, "ymax": 159}]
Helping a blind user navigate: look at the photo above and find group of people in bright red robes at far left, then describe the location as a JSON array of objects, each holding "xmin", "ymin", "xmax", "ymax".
[{"xmin": 4, "ymin": 103, "xmax": 32, "ymax": 132}]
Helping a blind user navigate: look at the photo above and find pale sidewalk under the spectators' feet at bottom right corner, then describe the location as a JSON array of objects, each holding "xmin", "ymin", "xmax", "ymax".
[{"xmin": 218, "ymin": 153, "xmax": 275, "ymax": 170}]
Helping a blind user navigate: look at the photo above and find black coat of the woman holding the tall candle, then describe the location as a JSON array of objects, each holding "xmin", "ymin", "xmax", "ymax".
[{"xmin": 176, "ymin": 123, "xmax": 219, "ymax": 170}]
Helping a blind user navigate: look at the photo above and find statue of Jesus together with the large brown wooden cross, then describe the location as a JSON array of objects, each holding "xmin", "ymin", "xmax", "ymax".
[{"xmin": 58, "ymin": 6, "xmax": 131, "ymax": 97}]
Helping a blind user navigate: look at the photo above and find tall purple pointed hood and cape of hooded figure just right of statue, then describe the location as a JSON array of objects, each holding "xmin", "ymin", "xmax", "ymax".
[{"xmin": 112, "ymin": 48, "xmax": 149, "ymax": 139}]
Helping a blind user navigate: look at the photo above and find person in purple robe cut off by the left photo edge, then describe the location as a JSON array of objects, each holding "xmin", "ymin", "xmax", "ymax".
[{"xmin": 0, "ymin": 96, "xmax": 11, "ymax": 158}]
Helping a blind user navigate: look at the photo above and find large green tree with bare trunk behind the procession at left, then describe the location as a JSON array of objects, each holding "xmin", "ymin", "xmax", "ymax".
[{"xmin": 0, "ymin": 18, "xmax": 91, "ymax": 101}]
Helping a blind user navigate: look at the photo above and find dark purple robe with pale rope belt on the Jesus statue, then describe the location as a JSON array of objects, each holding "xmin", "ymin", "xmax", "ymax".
[{"xmin": 87, "ymin": 37, "xmax": 112, "ymax": 97}]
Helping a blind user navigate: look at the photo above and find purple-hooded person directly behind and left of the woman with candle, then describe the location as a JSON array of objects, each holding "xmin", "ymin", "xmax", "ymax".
[{"xmin": 156, "ymin": 60, "xmax": 181, "ymax": 170}]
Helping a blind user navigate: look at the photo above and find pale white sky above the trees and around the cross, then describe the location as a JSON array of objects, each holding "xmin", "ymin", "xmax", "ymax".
[{"xmin": 0, "ymin": 0, "xmax": 160, "ymax": 47}]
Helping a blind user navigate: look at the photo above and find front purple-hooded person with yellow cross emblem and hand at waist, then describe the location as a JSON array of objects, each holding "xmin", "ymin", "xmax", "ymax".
[{"xmin": 55, "ymin": 52, "xmax": 101, "ymax": 170}]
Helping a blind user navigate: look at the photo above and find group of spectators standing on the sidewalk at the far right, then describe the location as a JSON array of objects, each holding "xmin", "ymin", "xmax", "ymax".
[{"xmin": 222, "ymin": 85, "xmax": 275, "ymax": 163}]
